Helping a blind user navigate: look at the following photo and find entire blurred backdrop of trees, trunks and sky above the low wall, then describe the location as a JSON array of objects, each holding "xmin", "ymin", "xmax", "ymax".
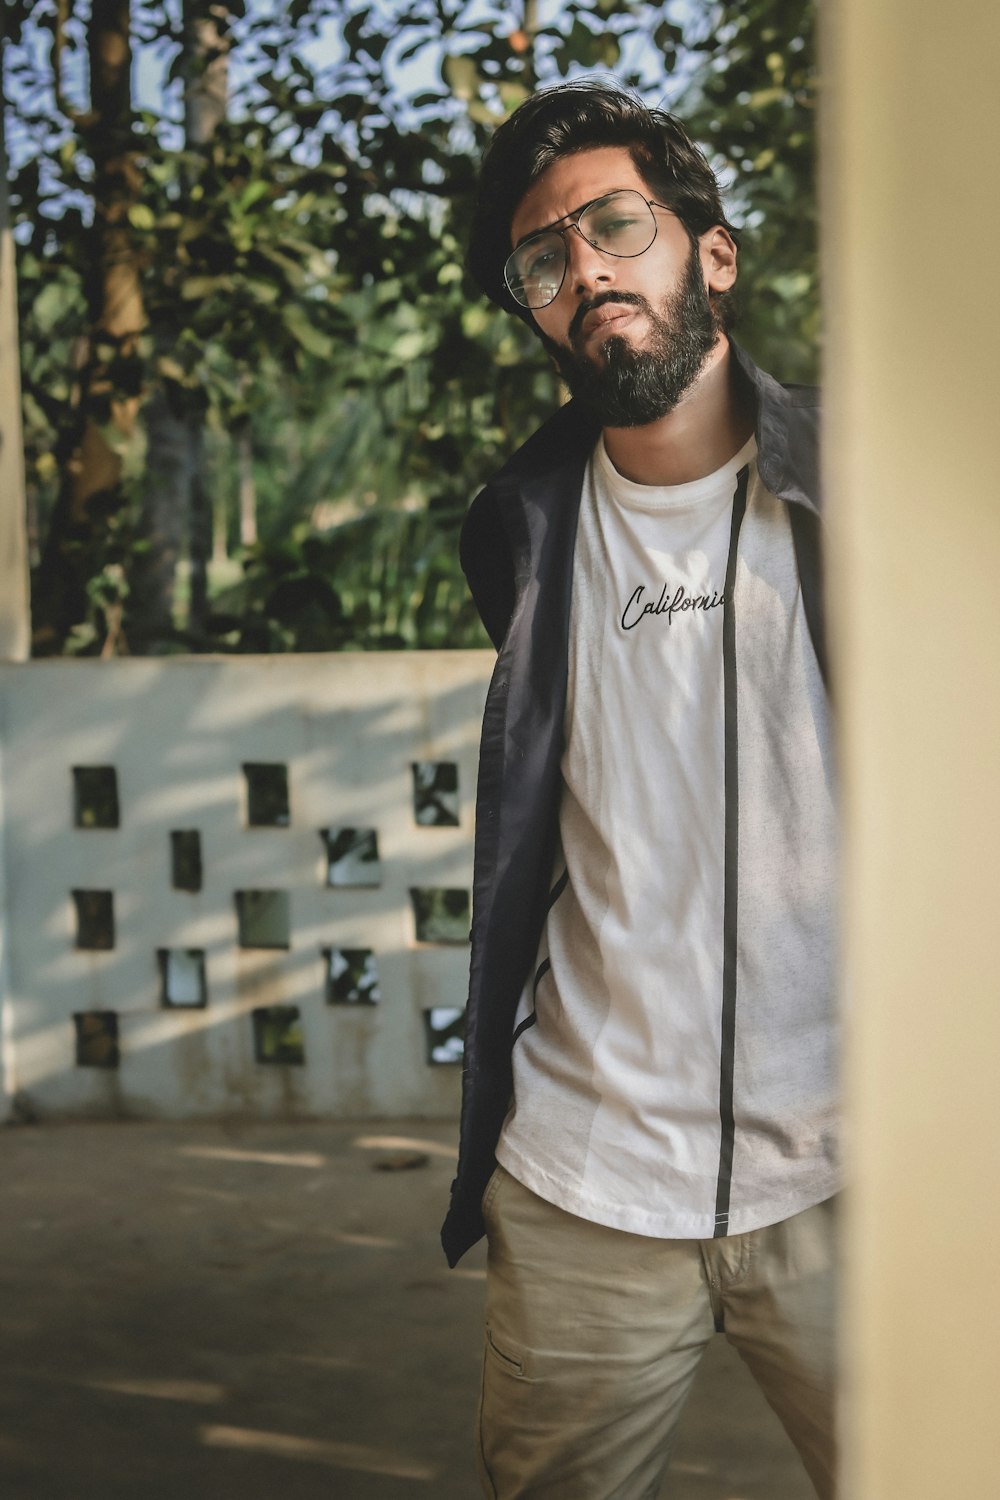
[{"xmin": 3, "ymin": 0, "xmax": 820, "ymax": 657}]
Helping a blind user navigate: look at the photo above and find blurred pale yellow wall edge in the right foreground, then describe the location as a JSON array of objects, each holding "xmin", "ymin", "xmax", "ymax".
[{"xmin": 823, "ymin": 0, "xmax": 1000, "ymax": 1500}]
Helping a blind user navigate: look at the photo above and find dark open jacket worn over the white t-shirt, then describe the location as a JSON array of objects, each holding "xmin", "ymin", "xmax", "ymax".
[{"xmin": 441, "ymin": 344, "xmax": 826, "ymax": 1266}]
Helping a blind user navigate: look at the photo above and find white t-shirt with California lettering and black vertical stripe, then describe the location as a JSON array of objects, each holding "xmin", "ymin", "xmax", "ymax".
[{"xmin": 498, "ymin": 440, "xmax": 837, "ymax": 1238}]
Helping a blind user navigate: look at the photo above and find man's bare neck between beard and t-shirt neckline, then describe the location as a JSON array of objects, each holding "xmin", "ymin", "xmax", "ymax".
[{"xmin": 604, "ymin": 336, "xmax": 754, "ymax": 485}]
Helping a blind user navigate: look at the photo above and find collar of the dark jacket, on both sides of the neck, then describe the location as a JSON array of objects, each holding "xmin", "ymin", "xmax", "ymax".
[{"xmin": 495, "ymin": 339, "xmax": 820, "ymax": 513}]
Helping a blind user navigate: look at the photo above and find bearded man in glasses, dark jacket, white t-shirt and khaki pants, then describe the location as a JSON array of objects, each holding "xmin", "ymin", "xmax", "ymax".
[{"xmin": 442, "ymin": 84, "xmax": 838, "ymax": 1500}]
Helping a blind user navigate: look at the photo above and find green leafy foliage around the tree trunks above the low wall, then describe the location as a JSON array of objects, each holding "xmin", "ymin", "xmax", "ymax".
[{"xmin": 7, "ymin": 0, "xmax": 819, "ymax": 651}]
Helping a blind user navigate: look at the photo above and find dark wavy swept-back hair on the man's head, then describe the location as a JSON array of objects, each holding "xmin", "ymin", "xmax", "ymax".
[{"xmin": 466, "ymin": 81, "xmax": 738, "ymax": 329}]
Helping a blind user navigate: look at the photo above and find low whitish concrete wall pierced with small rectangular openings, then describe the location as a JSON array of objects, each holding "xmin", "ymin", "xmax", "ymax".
[{"xmin": 0, "ymin": 653, "xmax": 493, "ymax": 1118}]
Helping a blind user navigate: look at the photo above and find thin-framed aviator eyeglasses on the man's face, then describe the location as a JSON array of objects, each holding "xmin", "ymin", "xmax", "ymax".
[{"xmin": 504, "ymin": 188, "xmax": 670, "ymax": 311}]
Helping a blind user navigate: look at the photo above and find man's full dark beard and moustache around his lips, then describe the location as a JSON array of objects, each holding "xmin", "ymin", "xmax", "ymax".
[{"xmin": 540, "ymin": 245, "xmax": 721, "ymax": 428}]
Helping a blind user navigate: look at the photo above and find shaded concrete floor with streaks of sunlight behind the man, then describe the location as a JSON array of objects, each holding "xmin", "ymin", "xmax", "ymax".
[{"xmin": 0, "ymin": 1122, "xmax": 813, "ymax": 1500}]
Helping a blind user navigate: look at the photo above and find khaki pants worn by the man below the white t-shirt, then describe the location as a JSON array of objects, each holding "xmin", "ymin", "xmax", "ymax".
[{"xmin": 478, "ymin": 1167, "xmax": 835, "ymax": 1500}]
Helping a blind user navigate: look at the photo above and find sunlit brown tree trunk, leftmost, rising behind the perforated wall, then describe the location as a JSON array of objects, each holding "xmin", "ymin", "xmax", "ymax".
[{"xmin": 33, "ymin": 0, "xmax": 144, "ymax": 656}]
